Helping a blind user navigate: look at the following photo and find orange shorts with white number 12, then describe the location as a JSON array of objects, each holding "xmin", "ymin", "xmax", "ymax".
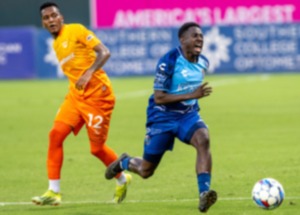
[{"xmin": 54, "ymin": 93, "xmax": 115, "ymax": 143}]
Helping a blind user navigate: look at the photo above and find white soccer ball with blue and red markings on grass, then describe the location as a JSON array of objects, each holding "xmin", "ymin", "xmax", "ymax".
[{"xmin": 252, "ymin": 178, "xmax": 284, "ymax": 210}]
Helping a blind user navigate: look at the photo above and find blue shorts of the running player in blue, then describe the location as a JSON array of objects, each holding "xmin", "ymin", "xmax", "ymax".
[{"xmin": 143, "ymin": 112, "xmax": 207, "ymax": 163}]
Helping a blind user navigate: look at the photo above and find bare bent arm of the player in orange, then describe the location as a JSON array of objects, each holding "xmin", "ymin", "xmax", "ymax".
[{"xmin": 75, "ymin": 43, "xmax": 110, "ymax": 90}]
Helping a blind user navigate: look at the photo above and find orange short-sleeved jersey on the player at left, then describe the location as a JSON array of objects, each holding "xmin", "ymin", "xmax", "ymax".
[{"xmin": 53, "ymin": 24, "xmax": 112, "ymax": 98}]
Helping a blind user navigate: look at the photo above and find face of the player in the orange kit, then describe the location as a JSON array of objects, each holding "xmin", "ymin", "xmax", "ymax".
[{"xmin": 41, "ymin": 6, "xmax": 63, "ymax": 36}]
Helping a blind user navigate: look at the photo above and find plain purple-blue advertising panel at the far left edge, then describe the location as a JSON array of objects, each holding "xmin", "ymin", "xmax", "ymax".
[{"xmin": 0, "ymin": 27, "xmax": 36, "ymax": 79}]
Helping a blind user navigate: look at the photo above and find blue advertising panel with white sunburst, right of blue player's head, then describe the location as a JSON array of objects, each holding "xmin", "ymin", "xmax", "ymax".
[{"xmin": 203, "ymin": 23, "xmax": 300, "ymax": 73}]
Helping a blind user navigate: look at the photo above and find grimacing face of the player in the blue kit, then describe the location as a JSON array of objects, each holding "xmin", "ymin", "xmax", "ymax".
[{"xmin": 180, "ymin": 27, "xmax": 203, "ymax": 56}]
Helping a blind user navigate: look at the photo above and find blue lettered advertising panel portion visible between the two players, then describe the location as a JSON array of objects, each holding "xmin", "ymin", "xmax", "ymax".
[{"xmin": 95, "ymin": 28, "xmax": 177, "ymax": 76}]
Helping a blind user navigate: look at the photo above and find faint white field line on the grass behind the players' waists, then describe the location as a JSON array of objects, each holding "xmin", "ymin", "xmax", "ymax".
[{"xmin": 116, "ymin": 74, "xmax": 270, "ymax": 100}]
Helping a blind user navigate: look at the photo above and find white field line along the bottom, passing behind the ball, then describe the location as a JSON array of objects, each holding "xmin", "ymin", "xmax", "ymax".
[{"xmin": 0, "ymin": 196, "xmax": 300, "ymax": 206}]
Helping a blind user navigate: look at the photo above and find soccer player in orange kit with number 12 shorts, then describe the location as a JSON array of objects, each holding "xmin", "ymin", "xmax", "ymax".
[{"xmin": 32, "ymin": 2, "xmax": 131, "ymax": 205}]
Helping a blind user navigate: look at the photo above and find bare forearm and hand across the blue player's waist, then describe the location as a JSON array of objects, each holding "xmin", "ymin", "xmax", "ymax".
[{"xmin": 154, "ymin": 82, "xmax": 212, "ymax": 104}]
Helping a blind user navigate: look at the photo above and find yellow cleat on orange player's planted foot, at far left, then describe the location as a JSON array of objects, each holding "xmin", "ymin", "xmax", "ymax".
[{"xmin": 31, "ymin": 190, "xmax": 61, "ymax": 206}]
